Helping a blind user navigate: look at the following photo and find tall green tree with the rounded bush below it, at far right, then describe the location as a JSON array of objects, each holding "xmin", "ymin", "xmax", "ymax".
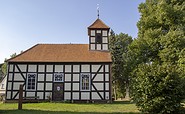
[{"xmin": 130, "ymin": 0, "xmax": 185, "ymax": 114}]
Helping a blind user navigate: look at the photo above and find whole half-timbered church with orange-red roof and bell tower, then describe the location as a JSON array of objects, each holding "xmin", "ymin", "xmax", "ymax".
[{"xmin": 6, "ymin": 18, "xmax": 112, "ymax": 102}]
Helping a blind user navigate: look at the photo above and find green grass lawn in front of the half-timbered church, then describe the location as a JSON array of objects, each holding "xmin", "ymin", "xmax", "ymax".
[{"xmin": 0, "ymin": 101, "xmax": 139, "ymax": 114}]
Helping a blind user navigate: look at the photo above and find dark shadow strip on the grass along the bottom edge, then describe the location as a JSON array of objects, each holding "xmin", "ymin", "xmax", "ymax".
[{"xmin": 0, "ymin": 109, "xmax": 140, "ymax": 114}]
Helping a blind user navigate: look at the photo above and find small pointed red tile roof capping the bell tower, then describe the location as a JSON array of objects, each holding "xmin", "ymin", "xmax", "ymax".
[{"xmin": 88, "ymin": 19, "xmax": 110, "ymax": 29}]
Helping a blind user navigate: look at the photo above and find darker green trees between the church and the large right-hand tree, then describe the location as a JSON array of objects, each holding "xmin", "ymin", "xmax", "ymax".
[{"xmin": 109, "ymin": 31, "xmax": 132, "ymax": 98}]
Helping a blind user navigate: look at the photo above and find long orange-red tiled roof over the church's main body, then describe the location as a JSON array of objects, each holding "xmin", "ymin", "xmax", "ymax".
[{"xmin": 8, "ymin": 44, "xmax": 112, "ymax": 62}]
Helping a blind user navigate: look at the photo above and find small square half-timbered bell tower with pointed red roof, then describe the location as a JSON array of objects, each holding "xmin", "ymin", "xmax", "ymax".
[{"xmin": 88, "ymin": 18, "xmax": 110, "ymax": 51}]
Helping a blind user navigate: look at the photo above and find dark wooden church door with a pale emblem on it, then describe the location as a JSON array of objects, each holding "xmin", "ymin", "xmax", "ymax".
[{"xmin": 53, "ymin": 82, "xmax": 64, "ymax": 101}]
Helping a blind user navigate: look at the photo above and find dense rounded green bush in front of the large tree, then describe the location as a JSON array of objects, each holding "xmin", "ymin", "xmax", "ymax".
[{"xmin": 133, "ymin": 64, "xmax": 184, "ymax": 114}]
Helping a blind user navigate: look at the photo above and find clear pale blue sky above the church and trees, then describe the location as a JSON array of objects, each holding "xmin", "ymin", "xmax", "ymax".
[{"xmin": 0, "ymin": 0, "xmax": 145, "ymax": 63}]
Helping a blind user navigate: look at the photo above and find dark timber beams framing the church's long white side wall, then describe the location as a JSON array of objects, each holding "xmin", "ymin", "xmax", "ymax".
[{"xmin": 6, "ymin": 62, "xmax": 112, "ymax": 102}]
